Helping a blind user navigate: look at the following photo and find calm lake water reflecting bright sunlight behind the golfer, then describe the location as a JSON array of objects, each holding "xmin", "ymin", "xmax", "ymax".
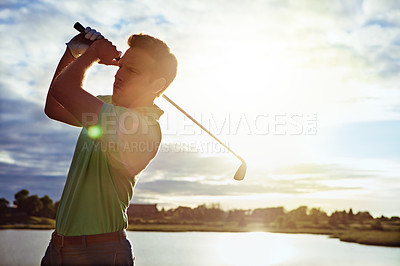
[{"xmin": 0, "ymin": 230, "xmax": 400, "ymax": 266}]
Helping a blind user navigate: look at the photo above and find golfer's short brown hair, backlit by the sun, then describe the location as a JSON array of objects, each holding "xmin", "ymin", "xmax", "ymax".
[{"xmin": 128, "ymin": 33, "xmax": 178, "ymax": 96}]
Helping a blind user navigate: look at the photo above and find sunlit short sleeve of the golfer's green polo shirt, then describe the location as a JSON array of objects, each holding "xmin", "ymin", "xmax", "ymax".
[{"xmin": 97, "ymin": 103, "xmax": 161, "ymax": 176}]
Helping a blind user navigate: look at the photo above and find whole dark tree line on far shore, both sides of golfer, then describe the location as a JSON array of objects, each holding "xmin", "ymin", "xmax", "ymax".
[{"xmin": 0, "ymin": 189, "xmax": 400, "ymax": 229}]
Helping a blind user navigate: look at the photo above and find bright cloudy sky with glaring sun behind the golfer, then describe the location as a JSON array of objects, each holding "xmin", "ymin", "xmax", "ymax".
[{"xmin": 0, "ymin": 0, "xmax": 400, "ymax": 217}]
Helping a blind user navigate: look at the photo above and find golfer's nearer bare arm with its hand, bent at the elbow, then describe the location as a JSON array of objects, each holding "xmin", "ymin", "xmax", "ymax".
[{"xmin": 49, "ymin": 39, "xmax": 120, "ymax": 128}]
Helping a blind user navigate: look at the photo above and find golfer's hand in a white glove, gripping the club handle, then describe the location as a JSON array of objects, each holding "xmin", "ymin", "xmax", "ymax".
[{"xmin": 67, "ymin": 27, "xmax": 104, "ymax": 58}]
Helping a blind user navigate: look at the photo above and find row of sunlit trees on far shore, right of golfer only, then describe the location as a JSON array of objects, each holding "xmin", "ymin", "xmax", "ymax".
[{"xmin": 153, "ymin": 204, "xmax": 400, "ymax": 229}]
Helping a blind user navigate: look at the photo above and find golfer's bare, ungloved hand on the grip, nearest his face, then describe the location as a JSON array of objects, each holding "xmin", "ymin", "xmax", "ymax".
[{"xmin": 87, "ymin": 39, "xmax": 122, "ymax": 66}]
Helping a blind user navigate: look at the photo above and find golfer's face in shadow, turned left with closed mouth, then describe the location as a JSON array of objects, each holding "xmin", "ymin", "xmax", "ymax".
[{"xmin": 112, "ymin": 48, "xmax": 158, "ymax": 108}]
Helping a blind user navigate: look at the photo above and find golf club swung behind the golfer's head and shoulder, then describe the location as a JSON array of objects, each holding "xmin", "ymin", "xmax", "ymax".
[{"xmin": 74, "ymin": 22, "xmax": 247, "ymax": 181}]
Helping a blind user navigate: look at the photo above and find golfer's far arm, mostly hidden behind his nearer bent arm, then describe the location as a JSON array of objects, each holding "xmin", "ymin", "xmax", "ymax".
[{"xmin": 44, "ymin": 47, "xmax": 82, "ymax": 127}]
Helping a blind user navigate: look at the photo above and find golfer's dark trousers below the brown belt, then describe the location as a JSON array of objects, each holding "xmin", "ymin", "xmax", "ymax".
[{"xmin": 41, "ymin": 231, "xmax": 134, "ymax": 266}]
